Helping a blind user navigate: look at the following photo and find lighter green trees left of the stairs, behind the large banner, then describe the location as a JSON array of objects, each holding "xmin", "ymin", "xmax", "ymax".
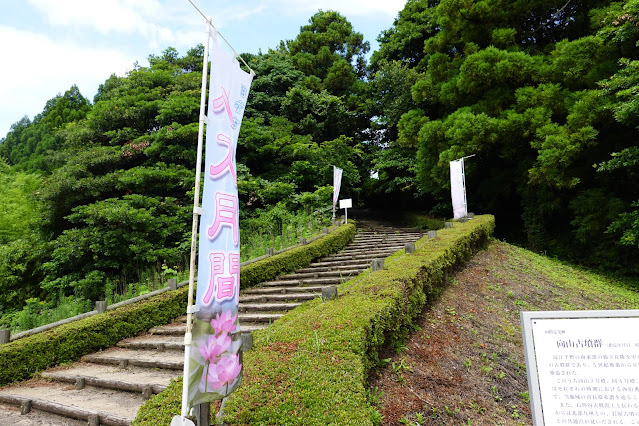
[{"xmin": 0, "ymin": 12, "xmax": 368, "ymax": 318}]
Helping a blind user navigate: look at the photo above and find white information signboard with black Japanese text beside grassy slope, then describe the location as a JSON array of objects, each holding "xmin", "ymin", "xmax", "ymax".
[{"xmin": 521, "ymin": 310, "xmax": 639, "ymax": 425}]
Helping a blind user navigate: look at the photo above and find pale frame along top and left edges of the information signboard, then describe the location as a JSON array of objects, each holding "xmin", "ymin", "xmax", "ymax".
[{"xmin": 520, "ymin": 309, "xmax": 639, "ymax": 426}]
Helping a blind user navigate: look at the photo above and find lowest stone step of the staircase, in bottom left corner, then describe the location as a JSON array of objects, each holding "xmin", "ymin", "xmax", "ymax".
[{"xmin": 0, "ymin": 379, "xmax": 145, "ymax": 426}]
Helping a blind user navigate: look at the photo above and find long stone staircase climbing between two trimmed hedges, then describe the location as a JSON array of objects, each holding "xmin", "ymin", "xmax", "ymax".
[{"xmin": 0, "ymin": 221, "xmax": 423, "ymax": 426}]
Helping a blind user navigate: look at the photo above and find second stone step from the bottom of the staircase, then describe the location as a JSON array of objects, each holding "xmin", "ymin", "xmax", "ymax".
[{"xmin": 41, "ymin": 362, "xmax": 180, "ymax": 396}]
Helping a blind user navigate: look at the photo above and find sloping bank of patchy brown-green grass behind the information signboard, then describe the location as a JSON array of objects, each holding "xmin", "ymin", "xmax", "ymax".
[{"xmin": 369, "ymin": 241, "xmax": 639, "ymax": 425}]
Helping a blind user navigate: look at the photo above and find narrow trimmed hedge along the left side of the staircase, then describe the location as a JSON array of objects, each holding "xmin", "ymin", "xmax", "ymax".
[{"xmin": 0, "ymin": 223, "xmax": 355, "ymax": 388}]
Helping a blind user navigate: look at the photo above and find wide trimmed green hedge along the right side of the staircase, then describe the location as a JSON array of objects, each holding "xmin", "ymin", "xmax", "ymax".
[{"xmin": 134, "ymin": 216, "xmax": 495, "ymax": 425}]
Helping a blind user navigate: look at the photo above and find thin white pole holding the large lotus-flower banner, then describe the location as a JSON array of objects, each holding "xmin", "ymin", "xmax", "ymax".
[{"xmin": 181, "ymin": 17, "xmax": 211, "ymax": 417}]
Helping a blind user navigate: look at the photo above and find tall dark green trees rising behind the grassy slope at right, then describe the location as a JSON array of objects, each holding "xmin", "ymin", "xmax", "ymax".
[{"xmin": 372, "ymin": 0, "xmax": 639, "ymax": 272}]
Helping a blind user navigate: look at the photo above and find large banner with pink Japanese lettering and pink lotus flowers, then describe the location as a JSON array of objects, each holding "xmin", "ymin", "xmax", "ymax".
[{"xmin": 184, "ymin": 32, "xmax": 252, "ymax": 406}]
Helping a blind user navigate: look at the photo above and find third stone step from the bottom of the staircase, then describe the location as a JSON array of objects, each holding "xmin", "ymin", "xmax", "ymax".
[{"xmin": 82, "ymin": 347, "xmax": 184, "ymax": 370}]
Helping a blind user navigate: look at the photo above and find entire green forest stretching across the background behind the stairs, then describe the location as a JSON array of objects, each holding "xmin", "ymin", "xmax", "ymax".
[{"xmin": 0, "ymin": 0, "xmax": 639, "ymax": 328}]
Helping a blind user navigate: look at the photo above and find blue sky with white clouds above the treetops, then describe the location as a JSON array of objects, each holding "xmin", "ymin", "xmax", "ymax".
[{"xmin": 0, "ymin": 0, "xmax": 406, "ymax": 139}]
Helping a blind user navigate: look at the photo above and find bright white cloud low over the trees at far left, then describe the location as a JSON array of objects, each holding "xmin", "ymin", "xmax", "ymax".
[{"xmin": 0, "ymin": 25, "xmax": 135, "ymax": 137}]
